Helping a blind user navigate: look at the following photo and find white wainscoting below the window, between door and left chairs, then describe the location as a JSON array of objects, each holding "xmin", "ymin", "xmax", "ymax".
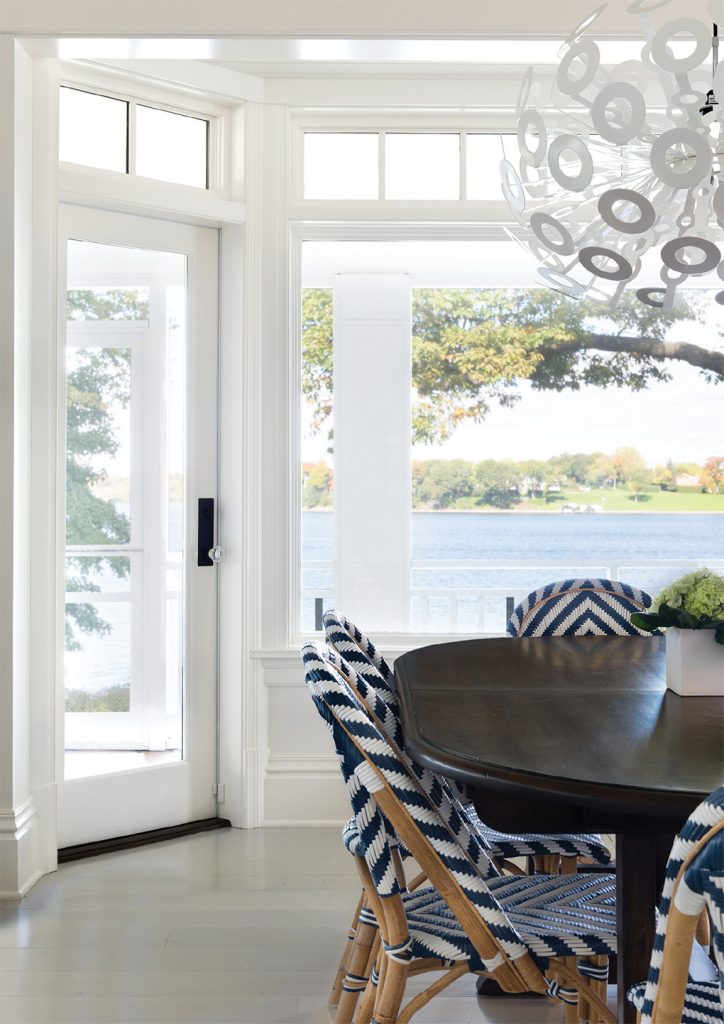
[{"xmin": 258, "ymin": 651, "xmax": 350, "ymax": 826}]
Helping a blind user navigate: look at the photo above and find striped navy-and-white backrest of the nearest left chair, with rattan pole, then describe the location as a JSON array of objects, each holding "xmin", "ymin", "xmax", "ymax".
[{"xmin": 302, "ymin": 644, "xmax": 546, "ymax": 991}]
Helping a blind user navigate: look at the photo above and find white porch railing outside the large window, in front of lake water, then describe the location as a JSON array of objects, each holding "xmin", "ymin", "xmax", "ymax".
[{"xmin": 301, "ymin": 558, "xmax": 724, "ymax": 633}]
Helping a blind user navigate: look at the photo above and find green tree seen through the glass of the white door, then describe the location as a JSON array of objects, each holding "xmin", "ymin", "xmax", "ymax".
[{"xmin": 66, "ymin": 289, "xmax": 148, "ymax": 650}]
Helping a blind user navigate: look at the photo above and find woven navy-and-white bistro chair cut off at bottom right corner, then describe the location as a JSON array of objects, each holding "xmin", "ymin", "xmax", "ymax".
[{"xmin": 627, "ymin": 786, "xmax": 724, "ymax": 1024}]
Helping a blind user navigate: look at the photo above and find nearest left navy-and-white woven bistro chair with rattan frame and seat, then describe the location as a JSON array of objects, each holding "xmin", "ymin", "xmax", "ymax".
[{"xmin": 302, "ymin": 644, "xmax": 615, "ymax": 1024}]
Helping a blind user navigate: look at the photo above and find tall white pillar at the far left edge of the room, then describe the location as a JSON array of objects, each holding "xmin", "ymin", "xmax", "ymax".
[{"xmin": 0, "ymin": 35, "xmax": 40, "ymax": 898}]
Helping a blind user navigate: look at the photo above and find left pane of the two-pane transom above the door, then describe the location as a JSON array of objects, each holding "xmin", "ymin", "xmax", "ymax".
[{"xmin": 58, "ymin": 86, "xmax": 128, "ymax": 174}]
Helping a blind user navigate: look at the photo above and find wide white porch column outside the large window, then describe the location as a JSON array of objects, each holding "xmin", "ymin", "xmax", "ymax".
[{"xmin": 334, "ymin": 273, "xmax": 412, "ymax": 633}]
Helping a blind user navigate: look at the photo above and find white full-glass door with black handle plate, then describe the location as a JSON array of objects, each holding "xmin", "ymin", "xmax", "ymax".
[{"xmin": 58, "ymin": 207, "xmax": 218, "ymax": 848}]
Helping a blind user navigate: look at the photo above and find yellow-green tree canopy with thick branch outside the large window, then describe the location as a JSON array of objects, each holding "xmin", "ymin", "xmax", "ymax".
[{"xmin": 302, "ymin": 289, "xmax": 724, "ymax": 443}]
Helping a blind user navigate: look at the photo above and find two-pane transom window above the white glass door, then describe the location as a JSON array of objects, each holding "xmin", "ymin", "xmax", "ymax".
[{"xmin": 59, "ymin": 85, "xmax": 210, "ymax": 188}]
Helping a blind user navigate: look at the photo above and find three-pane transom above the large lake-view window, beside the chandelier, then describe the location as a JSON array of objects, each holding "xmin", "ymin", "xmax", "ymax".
[{"xmin": 303, "ymin": 131, "xmax": 517, "ymax": 201}]
